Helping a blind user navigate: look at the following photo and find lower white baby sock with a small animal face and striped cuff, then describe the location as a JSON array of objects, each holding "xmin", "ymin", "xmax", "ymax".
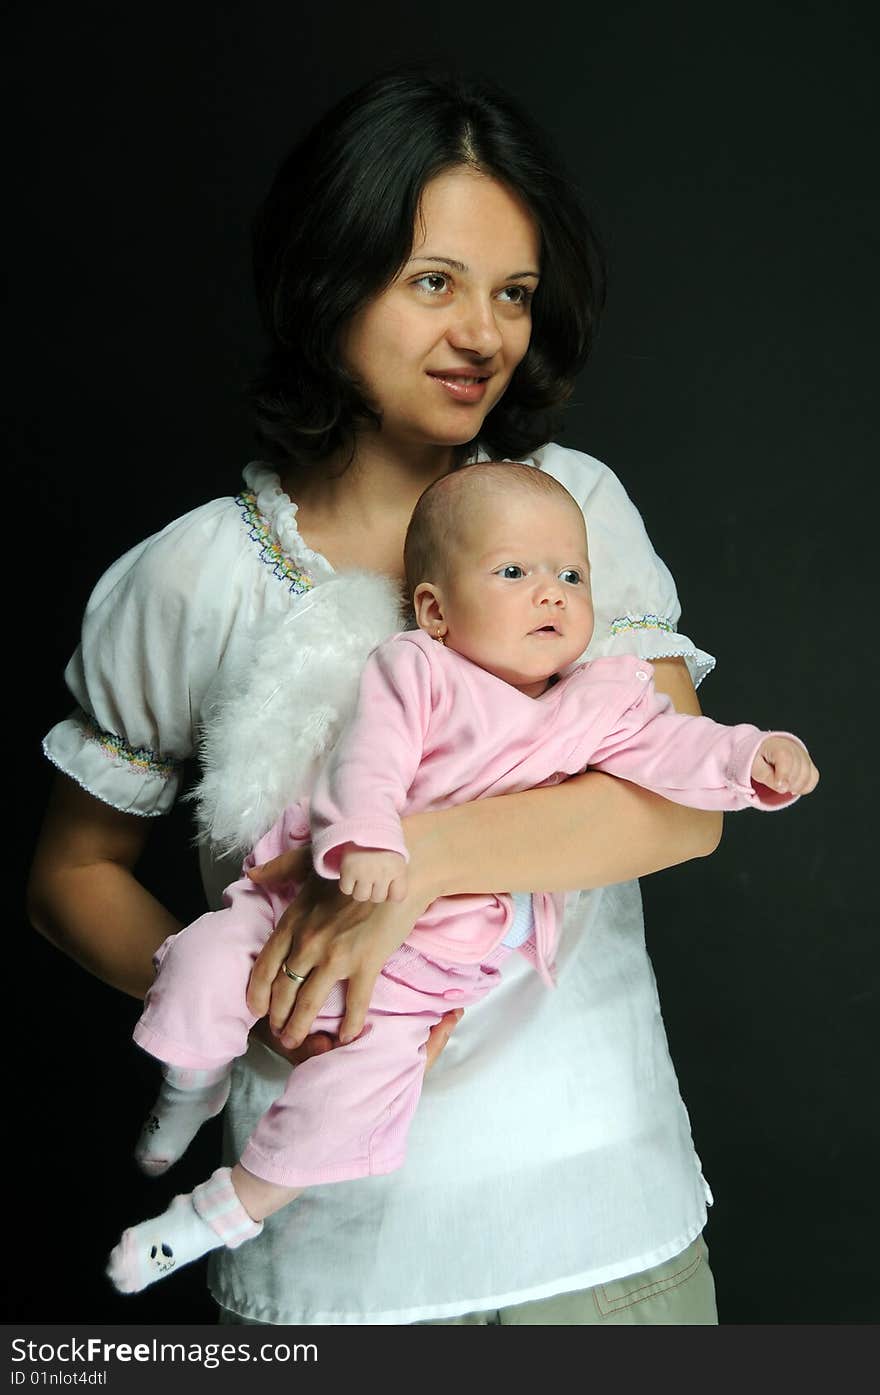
[{"xmin": 106, "ymin": 1168, "xmax": 262, "ymax": 1293}]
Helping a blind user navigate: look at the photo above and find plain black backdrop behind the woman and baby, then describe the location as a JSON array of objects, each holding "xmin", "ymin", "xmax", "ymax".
[{"xmin": 3, "ymin": 0, "xmax": 880, "ymax": 1324}]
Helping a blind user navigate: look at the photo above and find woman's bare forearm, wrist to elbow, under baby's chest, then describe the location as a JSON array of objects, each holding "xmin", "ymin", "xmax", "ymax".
[{"xmin": 404, "ymin": 773, "xmax": 721, "ymax": 900}]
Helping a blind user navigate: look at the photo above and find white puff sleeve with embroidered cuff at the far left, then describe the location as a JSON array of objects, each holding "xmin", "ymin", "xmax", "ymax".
[{"xmin": 43, "ymin": 499, "xmax": 251, "ymax": 816}]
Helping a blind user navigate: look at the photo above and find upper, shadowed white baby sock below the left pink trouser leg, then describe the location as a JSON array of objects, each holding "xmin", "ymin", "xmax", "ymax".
[{"xmin": 134, "ymin": 1064, "xmax": 232, "ymax": 1177}]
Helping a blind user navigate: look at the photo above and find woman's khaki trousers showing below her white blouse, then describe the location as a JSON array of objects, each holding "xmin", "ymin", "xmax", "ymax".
[{"xmin": 219, "ymin": 1236, "xmax": 718, "ymax": 1327}]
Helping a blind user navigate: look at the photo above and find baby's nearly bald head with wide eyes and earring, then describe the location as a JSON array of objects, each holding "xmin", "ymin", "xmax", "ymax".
[{"xmin": 404, "ymin": 460, "xmax": 593, "ymax": 698}]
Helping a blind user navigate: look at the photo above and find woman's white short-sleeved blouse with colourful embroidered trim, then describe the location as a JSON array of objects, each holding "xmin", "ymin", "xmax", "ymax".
[{"xmin": 45, "ymin": 445, "xmax": 714, "ymax": 1325}]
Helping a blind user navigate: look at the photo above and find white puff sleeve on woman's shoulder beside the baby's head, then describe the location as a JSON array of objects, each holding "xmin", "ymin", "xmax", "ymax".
[{"xmin": 536, "ymin": 445, "xmax": 715, "ymax": 688}]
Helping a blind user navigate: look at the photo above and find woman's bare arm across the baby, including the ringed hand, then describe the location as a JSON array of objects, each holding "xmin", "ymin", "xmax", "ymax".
[{"xmin": 248, "ymin": 658, "xmax": 721, "ymax": 1046}]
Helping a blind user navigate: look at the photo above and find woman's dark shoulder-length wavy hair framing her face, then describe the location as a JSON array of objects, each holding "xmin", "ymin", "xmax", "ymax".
[{"xmin": 252, "ymin": 70, "xmax": 604, "ymax": 465}]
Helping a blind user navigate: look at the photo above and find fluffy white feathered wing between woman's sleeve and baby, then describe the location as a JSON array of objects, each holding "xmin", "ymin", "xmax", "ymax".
[{"xmin": 187, "ymin": 572, "xmax": 403, "ymax": 854}]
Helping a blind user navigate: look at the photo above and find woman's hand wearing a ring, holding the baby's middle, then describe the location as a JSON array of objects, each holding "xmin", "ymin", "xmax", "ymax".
[{"xmin": 247, "ymin": 848, "xmax": 425, "ymax": 1048}]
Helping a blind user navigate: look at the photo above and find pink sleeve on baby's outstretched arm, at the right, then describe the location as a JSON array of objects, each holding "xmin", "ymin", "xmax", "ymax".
[{"xmin": 590, "ymin": 664, "xmax": 803, "ymax": 810}]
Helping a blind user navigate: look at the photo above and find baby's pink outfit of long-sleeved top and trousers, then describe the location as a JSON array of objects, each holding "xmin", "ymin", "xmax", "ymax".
[{"xmin": 134, "ymin": 631, "xmax": 796, "ymax": 1187}]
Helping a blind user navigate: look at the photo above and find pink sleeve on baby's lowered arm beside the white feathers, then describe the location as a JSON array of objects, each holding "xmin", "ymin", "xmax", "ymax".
[{"xmin": 311, "ymin": 639, "xmax": 431, "ymax": 877}]
